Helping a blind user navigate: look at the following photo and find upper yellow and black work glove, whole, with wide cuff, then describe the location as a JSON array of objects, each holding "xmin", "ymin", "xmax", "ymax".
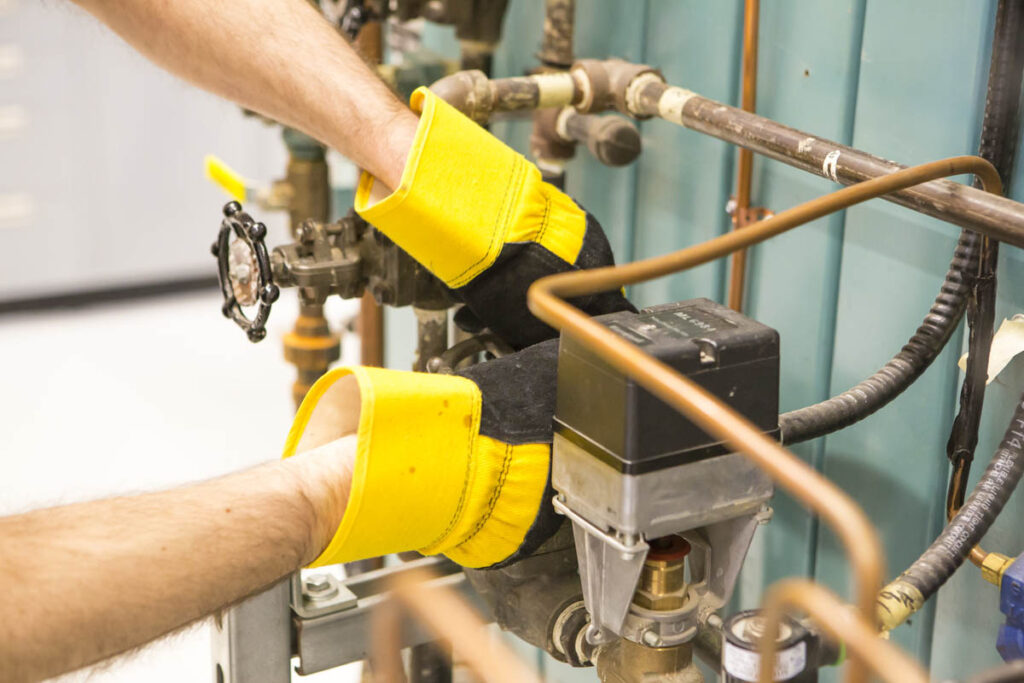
[{"xmin": 355, "ymin": 88, "xmax": 633, "ymax": 348}]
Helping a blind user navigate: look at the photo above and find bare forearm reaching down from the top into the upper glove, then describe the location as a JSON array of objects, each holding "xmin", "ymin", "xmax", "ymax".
[{"xmin": 75, "ymin": 0, "xmax": 417, "ymax": 188}]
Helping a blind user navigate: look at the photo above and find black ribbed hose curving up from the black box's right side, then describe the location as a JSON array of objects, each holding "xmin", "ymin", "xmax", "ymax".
[{"xmin": 778, "ymin": 230, "xmax": 981, "ymax": 443}]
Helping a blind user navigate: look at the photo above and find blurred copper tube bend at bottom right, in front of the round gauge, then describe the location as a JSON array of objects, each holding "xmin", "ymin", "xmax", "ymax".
[{"xmin": 760, "ymin": 579, "xmax": 929, "ymax": 683}]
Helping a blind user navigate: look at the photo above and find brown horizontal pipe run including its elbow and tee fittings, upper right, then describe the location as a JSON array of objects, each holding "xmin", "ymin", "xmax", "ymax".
[{"xmin": 431, "ymin": 59, "xmax": 1024, "ymax": 248}]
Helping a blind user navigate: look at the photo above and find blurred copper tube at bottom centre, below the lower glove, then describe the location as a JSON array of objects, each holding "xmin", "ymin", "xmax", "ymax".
[{"xmin": 372, "ymin": 571, "xmax": 541, "ymax": 683}]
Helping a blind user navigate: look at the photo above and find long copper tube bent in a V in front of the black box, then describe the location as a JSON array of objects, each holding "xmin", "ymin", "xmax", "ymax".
[{"xmin": 527, "ymin": 157, "xmax": 1001, "ymax": 681}]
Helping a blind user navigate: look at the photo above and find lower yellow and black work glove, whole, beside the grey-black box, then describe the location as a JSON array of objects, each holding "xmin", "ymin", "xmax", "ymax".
[{"xmin": 285, "ymin": 340, "xmax": 559, "ymax": 567}]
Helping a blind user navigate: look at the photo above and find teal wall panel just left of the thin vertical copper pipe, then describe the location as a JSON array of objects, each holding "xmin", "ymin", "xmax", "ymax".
[{"xmin": 631, "ymin": 0, "xmax": 742, "ymax": 306}]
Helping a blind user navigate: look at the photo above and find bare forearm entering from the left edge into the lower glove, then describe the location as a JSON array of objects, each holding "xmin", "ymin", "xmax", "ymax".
[{"xmin": 0, "ymin": 437, "xmax": 354, "ymax": 681}]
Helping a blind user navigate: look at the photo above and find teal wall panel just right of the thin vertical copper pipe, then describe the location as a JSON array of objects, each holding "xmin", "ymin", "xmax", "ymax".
[{"xmin": 736, "ymin": 0, "xmax": 864, "ymax": 608}]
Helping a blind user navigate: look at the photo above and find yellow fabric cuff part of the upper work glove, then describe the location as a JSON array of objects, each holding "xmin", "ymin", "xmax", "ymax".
[{"xmin": 354, "ymin": 88, "xmax": 587, "ymax": 288}]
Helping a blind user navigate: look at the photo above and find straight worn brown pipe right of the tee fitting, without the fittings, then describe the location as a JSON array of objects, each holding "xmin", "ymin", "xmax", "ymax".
[{"xmin": 626, "ymin": 76, "xmax": 1024, "ymax": 248}]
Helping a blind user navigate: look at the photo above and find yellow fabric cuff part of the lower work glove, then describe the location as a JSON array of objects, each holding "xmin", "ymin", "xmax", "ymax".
[{"xmin": 284, "ymin": 368, "xmax": 550, "ymax": 566}]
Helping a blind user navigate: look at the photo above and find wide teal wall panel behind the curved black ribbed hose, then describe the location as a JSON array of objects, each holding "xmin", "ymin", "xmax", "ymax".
[{"xmin": 816, "ymin": 0, "xmax": 990, "ymax": 660}]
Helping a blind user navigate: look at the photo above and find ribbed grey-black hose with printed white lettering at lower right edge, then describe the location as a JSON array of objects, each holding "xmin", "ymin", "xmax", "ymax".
[{"xmin": 894, "ymin": 396, "xmax": 1024, "ymax": 600}]
